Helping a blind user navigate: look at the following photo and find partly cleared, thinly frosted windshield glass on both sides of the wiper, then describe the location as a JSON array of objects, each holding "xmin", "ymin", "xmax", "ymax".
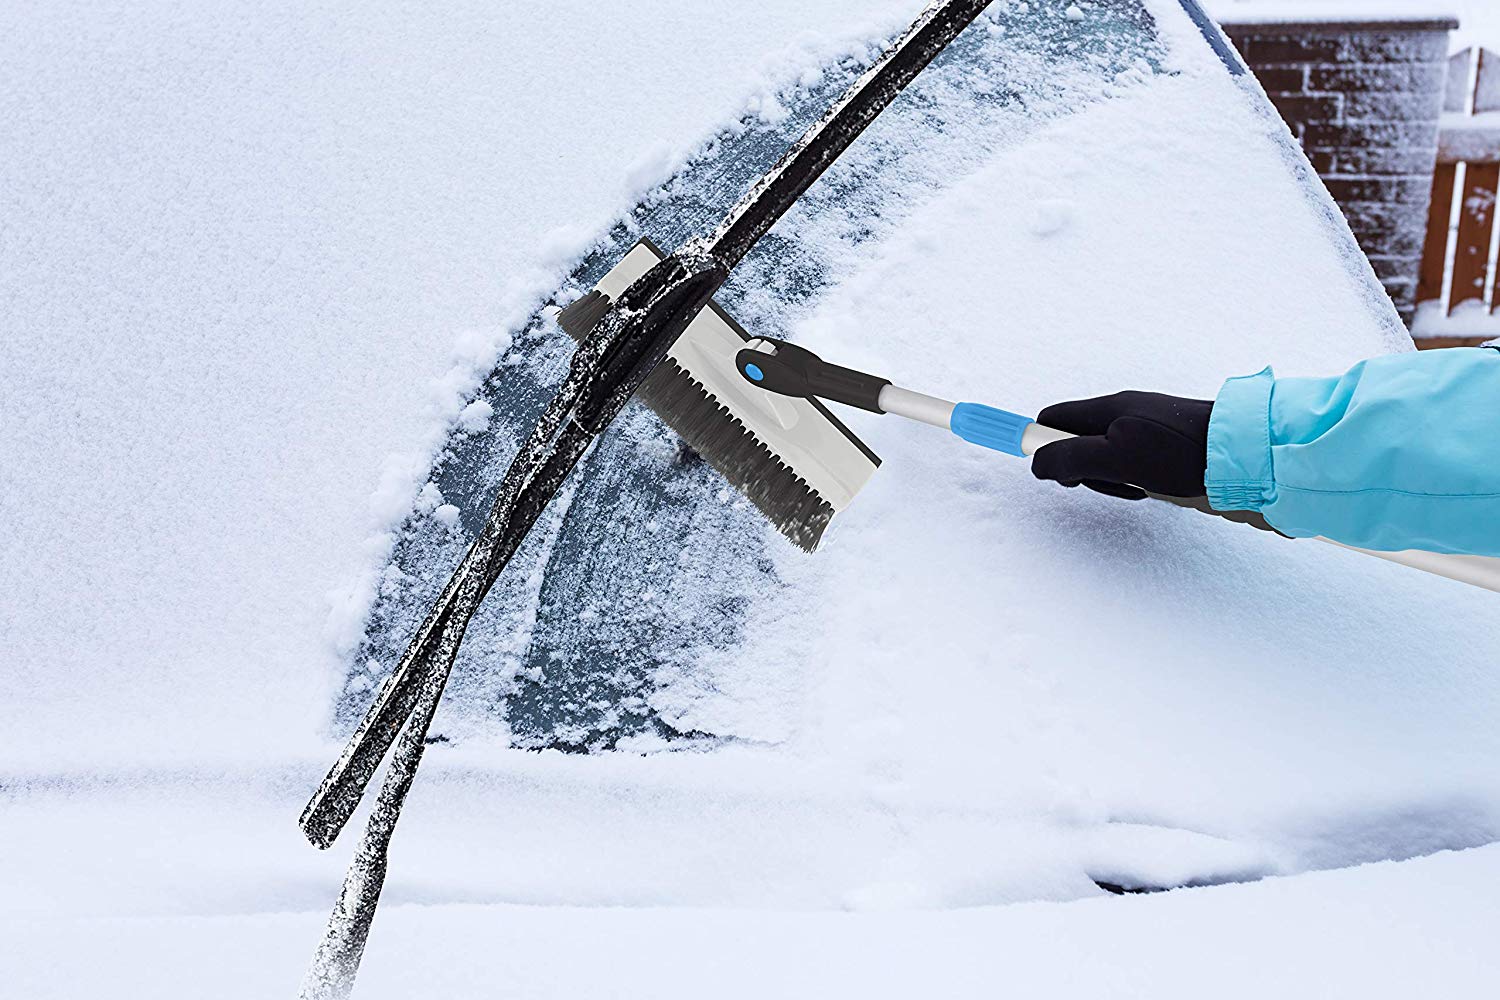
[{"xmin": 348, "ymin": 1, "xmax": 1194, "ymax": 751}]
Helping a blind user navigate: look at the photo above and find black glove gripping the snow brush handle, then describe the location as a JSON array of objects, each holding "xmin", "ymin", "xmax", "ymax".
[{"xmin": 1032, "ymin": 391, "xmax": 1214, "ymax": 499}]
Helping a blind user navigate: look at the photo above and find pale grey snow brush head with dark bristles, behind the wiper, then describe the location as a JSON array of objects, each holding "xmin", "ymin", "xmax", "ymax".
[{"xmin": 557, "ymin": 240, "xmax": 881, "ymax": 552}]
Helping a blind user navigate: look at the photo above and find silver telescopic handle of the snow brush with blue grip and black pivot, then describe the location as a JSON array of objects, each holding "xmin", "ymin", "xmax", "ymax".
[{"xmin": 735, "ymin": 337, "xmax": 1500, "ymax": 592}]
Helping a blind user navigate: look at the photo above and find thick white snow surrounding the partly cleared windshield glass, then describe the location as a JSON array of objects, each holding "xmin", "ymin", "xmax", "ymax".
[{"xmin": 0, "ymin": 0, "xmax": 1500, "ymax": 997}]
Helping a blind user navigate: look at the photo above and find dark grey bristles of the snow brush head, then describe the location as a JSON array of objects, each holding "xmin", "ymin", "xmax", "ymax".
[{"xmin": 557, "ymin": 288, "xmax": 834, "ymax": 552}]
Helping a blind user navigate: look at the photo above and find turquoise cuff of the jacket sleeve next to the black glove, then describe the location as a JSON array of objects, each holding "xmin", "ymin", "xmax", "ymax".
[{"xmin": 1203, "ymin": 367, "xmax": 1277, "ymax": 510}]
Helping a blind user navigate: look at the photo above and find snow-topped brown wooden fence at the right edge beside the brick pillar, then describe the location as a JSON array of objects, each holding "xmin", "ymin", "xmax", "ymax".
[{"xmin": 1413, "ymin": 48, "xmax": 1500, "ymax": 346}]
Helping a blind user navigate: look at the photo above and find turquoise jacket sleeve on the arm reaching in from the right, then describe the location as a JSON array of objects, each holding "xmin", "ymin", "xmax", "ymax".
[{"xmin": 1205, "ymin": 348, "xmax": 1500, "ymax": 556}]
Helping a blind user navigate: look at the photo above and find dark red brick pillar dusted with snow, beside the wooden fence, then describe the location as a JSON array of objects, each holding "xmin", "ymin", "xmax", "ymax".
[{"xmin": 1224, "ymin": 19, "xmax": 1458, "ymax": 322}]
